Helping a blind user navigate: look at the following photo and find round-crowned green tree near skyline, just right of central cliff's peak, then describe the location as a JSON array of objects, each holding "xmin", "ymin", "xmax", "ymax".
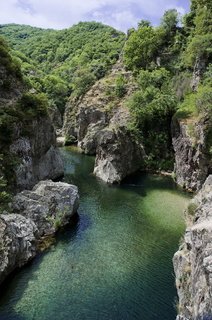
[{"xmin": 124, "ymin": 26, "xmax": 157, "ymax": 71}]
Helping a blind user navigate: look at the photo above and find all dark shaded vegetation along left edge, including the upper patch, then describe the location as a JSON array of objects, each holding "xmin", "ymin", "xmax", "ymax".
[{"xmin": 0, "ymin": 37, "xmax": 48, "ymax": 208}]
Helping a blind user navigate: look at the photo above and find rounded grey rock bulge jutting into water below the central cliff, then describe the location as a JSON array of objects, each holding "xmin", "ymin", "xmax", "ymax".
[{"xmin": 94, "ymin": 127, "xmax": 145, "ymax": 183}]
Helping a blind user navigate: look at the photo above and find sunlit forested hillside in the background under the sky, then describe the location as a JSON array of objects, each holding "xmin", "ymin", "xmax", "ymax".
[{"xmin": 0, "ymin": 22, "xmax": 125, "ymax": 112}]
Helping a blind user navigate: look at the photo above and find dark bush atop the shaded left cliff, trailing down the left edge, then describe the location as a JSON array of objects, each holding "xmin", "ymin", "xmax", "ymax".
[{"xmin": 0, "ymin": 93, "xmax": 48, "ymax": 211}]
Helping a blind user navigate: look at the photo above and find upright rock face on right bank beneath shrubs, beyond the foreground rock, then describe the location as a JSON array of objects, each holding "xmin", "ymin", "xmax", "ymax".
[{"xmin": 172, "ymin": 119, "xmax": 211, "ymax": 190}]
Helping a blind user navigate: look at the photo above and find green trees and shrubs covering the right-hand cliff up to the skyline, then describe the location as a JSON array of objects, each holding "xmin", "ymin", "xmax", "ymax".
[{"xmin": 124, "ymin": 0, "xmax": 212, "ymax": 170}]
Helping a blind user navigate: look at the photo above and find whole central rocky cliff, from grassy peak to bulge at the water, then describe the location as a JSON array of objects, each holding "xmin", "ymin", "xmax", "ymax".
[{"xmin": 63, "ymin": 62, "xmax": 145, "ymax": 183}]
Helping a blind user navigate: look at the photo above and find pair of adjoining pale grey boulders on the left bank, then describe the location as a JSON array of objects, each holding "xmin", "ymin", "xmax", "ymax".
[{"xmin": 0, "ymin": 181, "xmax": 79, "ymax": 283}]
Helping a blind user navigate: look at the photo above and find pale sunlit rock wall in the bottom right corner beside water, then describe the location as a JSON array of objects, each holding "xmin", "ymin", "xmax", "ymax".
[{"xmin": 173, "ymin": 175, "xmax": 212, "ymax": 320}]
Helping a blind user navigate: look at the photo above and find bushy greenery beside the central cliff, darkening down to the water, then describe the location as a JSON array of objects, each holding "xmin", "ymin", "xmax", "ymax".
[{"xmin": 128, "ymin": 69, "xmax": 177, "ymax": 170}]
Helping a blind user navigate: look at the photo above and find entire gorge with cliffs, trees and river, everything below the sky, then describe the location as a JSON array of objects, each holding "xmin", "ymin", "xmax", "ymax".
[{"xmin": 0, "ymin": 0, "xmax": 212, "ymax": 320}]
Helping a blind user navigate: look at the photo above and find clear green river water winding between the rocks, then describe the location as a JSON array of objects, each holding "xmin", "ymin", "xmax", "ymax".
[{"xmin": 0, "ymin": 148, "xmax": 190, "ymax": 320}]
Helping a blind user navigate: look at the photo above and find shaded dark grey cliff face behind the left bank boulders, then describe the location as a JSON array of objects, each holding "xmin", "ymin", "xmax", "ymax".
[{"xmin": 10, "ymin": 116, "xmax": 64, "ymax": 191}]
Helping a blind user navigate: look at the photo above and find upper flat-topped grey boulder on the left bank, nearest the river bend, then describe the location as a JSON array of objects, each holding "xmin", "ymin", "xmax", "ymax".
[{"xmin": 12, "ymin": 180, "xmax": 79, "ymax": 237}]
